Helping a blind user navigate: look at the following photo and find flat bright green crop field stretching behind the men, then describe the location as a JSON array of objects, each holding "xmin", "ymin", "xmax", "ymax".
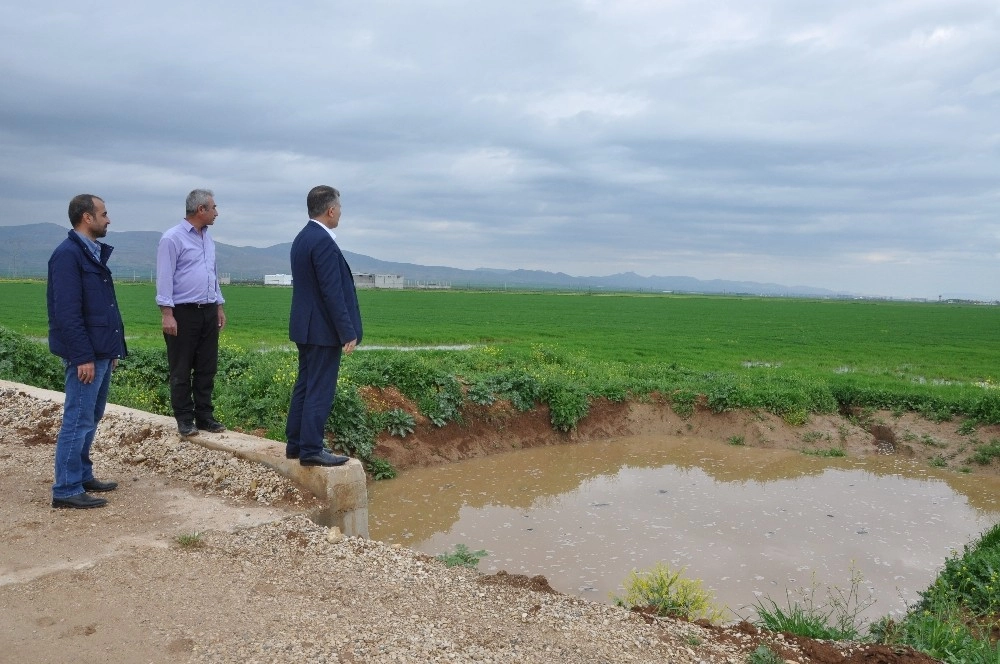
[{"xmin": 0, "ymin": 282, "xmax": 1000, "ymax": 382}]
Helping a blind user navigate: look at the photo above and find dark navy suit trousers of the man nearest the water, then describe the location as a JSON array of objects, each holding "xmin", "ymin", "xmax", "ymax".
[{"xmin": 285, "ymin": 344, "xmax": 343, "ymax": 458}]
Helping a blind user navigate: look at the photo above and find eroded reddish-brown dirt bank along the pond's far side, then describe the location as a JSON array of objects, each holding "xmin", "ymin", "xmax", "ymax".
[{"xmin": 363, "ymin": 388, "xmax": 1000, "ymax": 475}]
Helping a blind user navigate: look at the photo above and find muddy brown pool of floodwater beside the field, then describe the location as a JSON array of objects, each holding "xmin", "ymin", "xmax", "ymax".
[{"xmin": 368, "ymin": 437, "xmax": 1000, "ymax": 619}]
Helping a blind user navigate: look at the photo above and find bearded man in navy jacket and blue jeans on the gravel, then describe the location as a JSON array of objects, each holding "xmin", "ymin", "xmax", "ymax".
[{"xmin": 46, "ymin": 194, "xmax": 127, "ymax": 509}]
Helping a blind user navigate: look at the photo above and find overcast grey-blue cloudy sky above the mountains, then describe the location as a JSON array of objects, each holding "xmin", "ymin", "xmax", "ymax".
[{"xmin": 0, "ymin": 0, "xmax": 1000, "ymax": 298}]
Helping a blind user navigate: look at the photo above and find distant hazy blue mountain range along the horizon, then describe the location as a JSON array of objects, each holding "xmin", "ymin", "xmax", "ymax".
[{"xmin": 0, "ymin": 223, "xmax": 851, "ymax": 297}]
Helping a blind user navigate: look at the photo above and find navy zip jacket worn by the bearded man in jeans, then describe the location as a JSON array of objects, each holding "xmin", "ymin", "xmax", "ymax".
[{"xmin": 46, "ymin": 231, "xmax": 127, "ymax": 366}]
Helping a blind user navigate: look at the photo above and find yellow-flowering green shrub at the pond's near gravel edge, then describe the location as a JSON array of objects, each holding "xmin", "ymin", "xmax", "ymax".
[{"xmin": 612, "ymin": 563, "xmax": 725, "ymax": 622}]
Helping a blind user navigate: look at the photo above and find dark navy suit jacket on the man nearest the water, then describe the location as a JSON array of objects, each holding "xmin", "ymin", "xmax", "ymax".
[{"xmin": 288, "ymin": 221, "xmax": 361, "ymax": 346}]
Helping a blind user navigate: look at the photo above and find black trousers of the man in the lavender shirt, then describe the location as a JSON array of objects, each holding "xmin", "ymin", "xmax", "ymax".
[{"xmin": 163, "ymin": 305, "xmax": 219, "ymax": 422}]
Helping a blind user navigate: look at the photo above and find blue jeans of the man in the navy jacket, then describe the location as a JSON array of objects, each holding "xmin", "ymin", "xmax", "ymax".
[{"xmin": 52, "ymin": 360, "xmax": 111, "ymax": 498}]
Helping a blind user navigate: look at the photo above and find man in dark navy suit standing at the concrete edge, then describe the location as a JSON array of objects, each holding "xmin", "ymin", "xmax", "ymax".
[{"xmin": 285, "ymin": 185, "xmax": 361, "ymax": 466}]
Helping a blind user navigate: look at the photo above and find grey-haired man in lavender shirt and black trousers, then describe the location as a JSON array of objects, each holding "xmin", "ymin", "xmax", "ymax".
[{"xmin": 156, "ymin": 189, "xmax": 226, "ymax": 436}]
